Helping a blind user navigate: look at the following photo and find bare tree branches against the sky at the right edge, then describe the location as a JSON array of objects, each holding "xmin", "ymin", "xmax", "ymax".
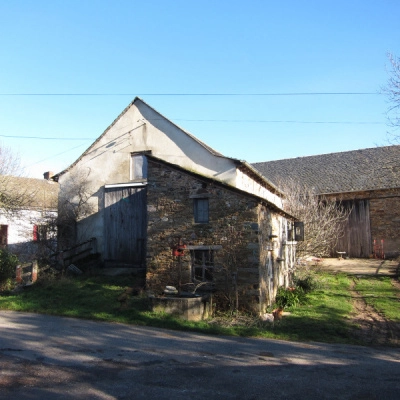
[{"xmin": 383, "ymin": 53, "xmax": 400, "ymax": 143}]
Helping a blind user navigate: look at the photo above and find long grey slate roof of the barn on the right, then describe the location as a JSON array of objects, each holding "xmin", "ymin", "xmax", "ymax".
[{"xmin": 252, "ymin": 146, "xmax": 400, "ymax": 194}]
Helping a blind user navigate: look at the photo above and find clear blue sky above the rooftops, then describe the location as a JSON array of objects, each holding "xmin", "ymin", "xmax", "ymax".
[{"xmin": 0, "ymin": 0, "xmax": 400, "ymax": 178}]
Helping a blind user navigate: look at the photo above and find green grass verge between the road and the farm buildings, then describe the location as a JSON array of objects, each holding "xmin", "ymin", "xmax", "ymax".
[{"xmin": 0, "ymin": 273, "xmax": 400, "ymax": 344}]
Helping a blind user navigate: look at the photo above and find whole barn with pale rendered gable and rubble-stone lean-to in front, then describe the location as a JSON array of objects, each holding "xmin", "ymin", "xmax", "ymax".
[{"xmin": 55, "ymin": 98, "xmax": 295, "ymax": 313}]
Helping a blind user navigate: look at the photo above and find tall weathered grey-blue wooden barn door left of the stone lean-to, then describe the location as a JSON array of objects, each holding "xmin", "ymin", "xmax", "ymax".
[{"xmin": 104, "ymin": 187, "xmax": 147, "ymax": 267}]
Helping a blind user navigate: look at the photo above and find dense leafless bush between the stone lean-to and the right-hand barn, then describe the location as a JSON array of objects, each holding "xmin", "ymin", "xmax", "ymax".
[{"xmin": 278, "ymin": 180, "xmax": 351, "ymax": 257}]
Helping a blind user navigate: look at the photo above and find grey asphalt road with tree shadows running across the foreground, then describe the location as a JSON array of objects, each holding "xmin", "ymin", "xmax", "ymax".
[{"xmin": 0, "ymin": 311, "xmax": 400, "ymax": 400}]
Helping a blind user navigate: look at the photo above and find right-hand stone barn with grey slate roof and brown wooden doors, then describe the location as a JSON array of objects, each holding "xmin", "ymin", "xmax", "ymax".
[{"xmin": 253, "ymin": 146, "xmax": 400, "ymax": 257}]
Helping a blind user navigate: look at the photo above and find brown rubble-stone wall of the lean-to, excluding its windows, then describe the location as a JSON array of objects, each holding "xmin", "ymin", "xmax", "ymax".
[{"xmin": 146, "ymin": 160, "xmax": 282, "ymax": 312}]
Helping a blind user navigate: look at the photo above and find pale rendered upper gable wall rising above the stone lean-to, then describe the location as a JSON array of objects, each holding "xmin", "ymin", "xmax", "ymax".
[{"xmin": 59, "ymin": 98, "xmax": 282, "ymax": 212}]
